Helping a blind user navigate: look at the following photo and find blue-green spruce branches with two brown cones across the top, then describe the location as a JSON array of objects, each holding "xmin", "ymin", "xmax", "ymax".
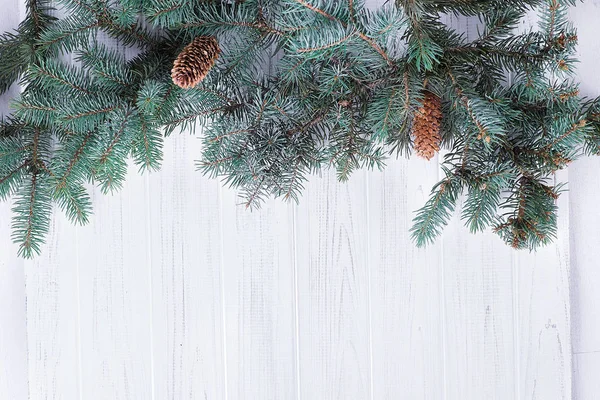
[{"xmin": 0, "ymin": 0, "xmax": 600, "ymax": 257}]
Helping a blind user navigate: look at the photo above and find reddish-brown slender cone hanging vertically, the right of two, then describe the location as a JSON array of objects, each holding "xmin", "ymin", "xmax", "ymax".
[{"xmin": 412, "ymin": 91, "xmax": 442, "ymax": 160}]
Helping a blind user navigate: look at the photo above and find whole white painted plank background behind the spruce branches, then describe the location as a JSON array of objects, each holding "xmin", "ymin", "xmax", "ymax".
[{"xmin": 0, "ymin": 0, "xmax": 600, "ymax": 400}]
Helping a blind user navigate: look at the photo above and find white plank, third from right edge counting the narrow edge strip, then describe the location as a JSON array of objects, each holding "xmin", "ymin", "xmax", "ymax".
[{"xmin": 441, "ymin": 212, "xmax": 519, "ymax": 400}]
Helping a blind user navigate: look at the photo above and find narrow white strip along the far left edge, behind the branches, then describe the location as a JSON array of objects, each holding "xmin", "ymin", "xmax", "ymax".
[{"xmin": 0, "ymin": 0, "xmax": 28, "ymax": 399}]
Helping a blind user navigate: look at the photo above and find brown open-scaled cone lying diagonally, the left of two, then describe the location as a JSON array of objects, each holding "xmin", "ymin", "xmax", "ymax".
[{"xmin": 171, "ymin": 36, "xmax": 221, "ymax": 89}]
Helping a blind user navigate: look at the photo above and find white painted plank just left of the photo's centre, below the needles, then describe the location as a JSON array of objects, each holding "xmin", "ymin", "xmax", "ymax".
[{"xmin": 221, "ymin": 189, "xmax": 297, "ymax": 400}]
